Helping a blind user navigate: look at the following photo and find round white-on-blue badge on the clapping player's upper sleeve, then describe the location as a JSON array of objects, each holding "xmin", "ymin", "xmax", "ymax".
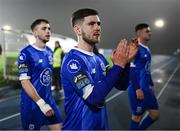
[{"xmin": 67, "ymin": 59, "xmax": 81, "ymax": 73}]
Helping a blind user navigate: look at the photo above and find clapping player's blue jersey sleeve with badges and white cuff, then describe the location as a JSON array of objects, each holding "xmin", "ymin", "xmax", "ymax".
[{"xmin": 61, "ymin": 56, "xmax": 93, "ymax": 99}]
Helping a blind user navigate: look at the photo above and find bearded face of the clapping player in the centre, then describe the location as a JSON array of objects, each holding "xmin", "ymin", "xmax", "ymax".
[{"xmin": 81, "ymin": 15, "xmax": 101, "ymax": 45}]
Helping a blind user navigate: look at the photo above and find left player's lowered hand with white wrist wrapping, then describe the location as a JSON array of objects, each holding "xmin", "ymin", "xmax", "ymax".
[{"xmin": 36, "ymin": 99, "xmax": 54, "ymax": 117}]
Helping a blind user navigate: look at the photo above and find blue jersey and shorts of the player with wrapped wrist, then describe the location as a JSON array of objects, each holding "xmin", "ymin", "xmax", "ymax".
[{"xmin": 18, "ymin": 45, "xmax": 62, "ymax": 130}]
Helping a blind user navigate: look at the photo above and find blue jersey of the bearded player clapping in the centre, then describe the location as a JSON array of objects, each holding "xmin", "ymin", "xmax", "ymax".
[{"xmin": 61, "ymin": 49, "xmax": 128, "ymax": 130}]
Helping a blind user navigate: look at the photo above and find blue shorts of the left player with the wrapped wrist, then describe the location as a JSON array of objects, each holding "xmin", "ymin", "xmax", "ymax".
[{"xmin": 21, "ymin": 103, "xmax": 62, "ymax": 130}]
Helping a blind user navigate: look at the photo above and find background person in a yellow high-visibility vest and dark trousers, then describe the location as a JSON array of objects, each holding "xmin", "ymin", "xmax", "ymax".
[{"xmin": 52, "ymin": 41, "xmax": 64, "ymax": 91}]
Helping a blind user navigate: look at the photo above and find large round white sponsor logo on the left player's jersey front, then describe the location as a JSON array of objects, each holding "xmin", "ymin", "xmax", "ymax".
[{"xmin": 40, "ymin": 68, "xmax": 51, "ymax": 86}]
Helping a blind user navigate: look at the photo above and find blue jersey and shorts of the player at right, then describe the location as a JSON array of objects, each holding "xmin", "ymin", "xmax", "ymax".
[{"xmin": 128, "ymin": 44, "xmax": 158, "ymax": 115}]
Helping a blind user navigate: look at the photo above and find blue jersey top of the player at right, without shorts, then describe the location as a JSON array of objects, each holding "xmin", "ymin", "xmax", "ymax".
[{"xmin": 129, "ymin": 44, "xmax": 153, "ymax": 91}]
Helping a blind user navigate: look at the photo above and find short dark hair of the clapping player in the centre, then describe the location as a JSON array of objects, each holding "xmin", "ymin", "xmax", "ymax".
[{"xmin": 71, "ymin": 8, "xmax": 98, "ymax": 26}]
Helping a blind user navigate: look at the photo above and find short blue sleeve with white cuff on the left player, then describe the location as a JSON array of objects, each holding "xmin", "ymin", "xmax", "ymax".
[{"xmin": 18, "ymin": 50, "xmax": 31, "ymax": 80}]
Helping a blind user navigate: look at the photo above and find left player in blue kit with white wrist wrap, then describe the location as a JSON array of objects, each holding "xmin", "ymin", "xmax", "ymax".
[{"xmin": 18, "ymin": 19, "xmax": 62, "ymax": 130}]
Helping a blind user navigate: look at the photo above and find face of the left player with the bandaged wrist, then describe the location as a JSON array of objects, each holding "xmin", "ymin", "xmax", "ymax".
[{"xmin": 33, "ymin": 22, "xmax": 51, "ymax": 43}]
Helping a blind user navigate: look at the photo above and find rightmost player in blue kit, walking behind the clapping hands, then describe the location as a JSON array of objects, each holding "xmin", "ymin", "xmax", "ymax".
[{"xmin": 128, "ymin": 23, "xmax": 160, "ymax": 130}]
